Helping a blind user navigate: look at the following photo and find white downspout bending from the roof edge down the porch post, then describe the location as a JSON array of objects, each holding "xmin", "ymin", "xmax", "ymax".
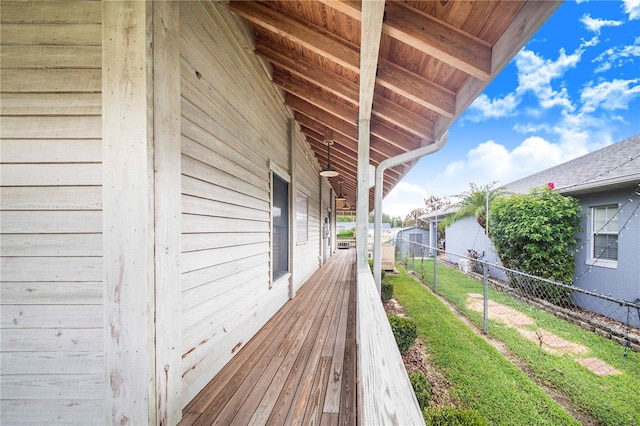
[{"xmin": 373, "ymin": 130, "xmax": 449, "ymax": 293}]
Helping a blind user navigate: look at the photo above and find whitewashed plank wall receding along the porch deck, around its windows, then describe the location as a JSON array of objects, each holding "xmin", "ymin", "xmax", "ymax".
[{"xmin": 180, "ymin": 2, "xmax": 320, "ymax": 406}]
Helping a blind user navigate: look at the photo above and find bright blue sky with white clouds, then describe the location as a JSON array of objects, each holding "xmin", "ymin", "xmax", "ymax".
[{"xmin": 382, "ymin": 0, "xmax": 640, "ymax": 218}]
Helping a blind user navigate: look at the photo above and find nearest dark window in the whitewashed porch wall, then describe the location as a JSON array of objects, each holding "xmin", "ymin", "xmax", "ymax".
[{"xmin": 271, "ymin": 173, "xmax": 289, "ymax": 281}]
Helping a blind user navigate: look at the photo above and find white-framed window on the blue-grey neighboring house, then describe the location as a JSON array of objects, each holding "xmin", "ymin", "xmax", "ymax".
[{"xmin": 592, "ymin": 204, "xmax": 618, "ymax": 262}]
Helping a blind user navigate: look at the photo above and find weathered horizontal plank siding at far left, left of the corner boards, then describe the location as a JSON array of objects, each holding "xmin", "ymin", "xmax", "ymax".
[{"xmin": 0, "ymin": 1, "xmax": 105, "ymax": 425}]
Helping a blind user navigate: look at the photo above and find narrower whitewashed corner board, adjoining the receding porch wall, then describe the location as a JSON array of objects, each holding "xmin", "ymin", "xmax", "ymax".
[{"xmin": 153, "ymin": 1, "xmax": 182, "ymax": 425}]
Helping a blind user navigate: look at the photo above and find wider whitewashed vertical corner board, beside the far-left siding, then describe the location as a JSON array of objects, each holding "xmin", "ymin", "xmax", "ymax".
[{"xmin": 102, "ymin": 1, "xmax": 157, "ymax": 425}]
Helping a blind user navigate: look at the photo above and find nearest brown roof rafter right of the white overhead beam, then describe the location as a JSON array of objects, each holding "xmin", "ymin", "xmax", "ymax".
[{"xmin": 382, "ymin": 2, "xmax": 491, "ymax": 81}]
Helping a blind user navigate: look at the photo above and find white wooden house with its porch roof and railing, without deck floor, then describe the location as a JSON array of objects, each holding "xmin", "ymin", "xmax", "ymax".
[{"xmin": 0, "ymin": 0, "xmax": 560, "ymax": 426}]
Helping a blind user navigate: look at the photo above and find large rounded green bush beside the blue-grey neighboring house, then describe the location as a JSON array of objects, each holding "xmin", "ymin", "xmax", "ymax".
[{"xmin": 489, "ymin": 187, "xmax": 581, "ymax": 304}]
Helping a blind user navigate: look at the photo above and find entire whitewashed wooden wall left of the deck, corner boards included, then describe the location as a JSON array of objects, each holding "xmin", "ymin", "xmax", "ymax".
[{"xmin": 0, "ymin": 1, "xmax": 331, "ymax": 425}]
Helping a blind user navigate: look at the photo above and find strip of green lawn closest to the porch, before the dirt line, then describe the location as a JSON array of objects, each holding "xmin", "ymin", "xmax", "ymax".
[{"xmin": 388, "ymin": 264, "xmax": 579, "ymax": 425}]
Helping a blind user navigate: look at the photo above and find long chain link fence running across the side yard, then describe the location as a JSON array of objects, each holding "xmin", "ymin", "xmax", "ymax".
[{"xmin": 394, "ymin": 239, "xmax": 640, "ymax": 356}]
